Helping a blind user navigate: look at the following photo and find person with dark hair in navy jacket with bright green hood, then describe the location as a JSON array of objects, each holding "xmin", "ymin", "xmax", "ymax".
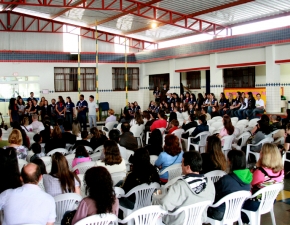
[{"xmin": 207, "ymin": 150, "xmax": 253, "ymax": 221}]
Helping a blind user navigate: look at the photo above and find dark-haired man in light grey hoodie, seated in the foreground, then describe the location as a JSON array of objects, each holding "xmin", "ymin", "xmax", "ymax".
[{"xmin": 157, "ymin": 151, "xmax": 215, "ymax": 225}]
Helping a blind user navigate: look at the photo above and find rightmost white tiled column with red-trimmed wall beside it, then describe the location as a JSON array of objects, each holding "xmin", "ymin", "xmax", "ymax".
[{"xmin": 265, "ymin": 45, "xmax": 281, "ymax": 113}]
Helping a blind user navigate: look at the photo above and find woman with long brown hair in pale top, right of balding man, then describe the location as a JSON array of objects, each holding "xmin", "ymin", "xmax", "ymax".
[{"xmin": 43, "ymin": 152, "xmax": 81, "ymax": 197}]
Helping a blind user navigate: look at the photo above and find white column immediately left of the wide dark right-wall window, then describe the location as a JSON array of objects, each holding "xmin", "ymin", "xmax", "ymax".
[{"xmin": 210, "ymin": 53, "xmax": 224, "ymax": 96}]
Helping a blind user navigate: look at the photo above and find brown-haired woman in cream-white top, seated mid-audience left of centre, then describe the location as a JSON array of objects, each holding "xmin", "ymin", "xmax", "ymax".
[{"xmin": 96, "ymin": 140, "xmax": 127, "ymax": 173}]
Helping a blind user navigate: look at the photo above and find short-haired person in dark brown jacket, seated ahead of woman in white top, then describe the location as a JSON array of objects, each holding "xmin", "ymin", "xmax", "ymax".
[{"xmin": 119, "ymin": 123, "xmax": 138, "ymax": 151}]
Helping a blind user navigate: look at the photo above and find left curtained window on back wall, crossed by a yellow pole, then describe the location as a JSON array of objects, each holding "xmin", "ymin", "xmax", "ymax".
[{"xmin": 54, "ymin": 67, "xmax": 96, "ymax": 92}]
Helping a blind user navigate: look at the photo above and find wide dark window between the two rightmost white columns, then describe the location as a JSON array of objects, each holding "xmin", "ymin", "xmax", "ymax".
[{"xmin": 224, "ymin": 67, "xmax": 255, "ymax": 88}]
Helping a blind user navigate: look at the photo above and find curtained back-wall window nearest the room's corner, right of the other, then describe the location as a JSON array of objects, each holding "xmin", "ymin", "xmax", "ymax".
[{"xmin": 112, "ymin": 67, "xmax": 139, "ymax": 91}]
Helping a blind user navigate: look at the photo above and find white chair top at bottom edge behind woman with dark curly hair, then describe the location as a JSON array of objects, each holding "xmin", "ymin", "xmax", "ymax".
[{"xmin": 75, "ymin": 213, "xmax": 118, "ymax": 225}]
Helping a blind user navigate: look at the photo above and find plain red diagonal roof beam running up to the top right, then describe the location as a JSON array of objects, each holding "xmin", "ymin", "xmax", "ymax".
[{"xmin": 125, "ymin": 0, "xmax": 255, "ymax": 35}]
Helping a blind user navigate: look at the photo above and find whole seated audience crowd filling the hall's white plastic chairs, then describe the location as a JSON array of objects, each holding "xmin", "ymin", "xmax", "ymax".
[{"xmin": 0, "ymin": 92, "xmax": 290, "ymax": 225}]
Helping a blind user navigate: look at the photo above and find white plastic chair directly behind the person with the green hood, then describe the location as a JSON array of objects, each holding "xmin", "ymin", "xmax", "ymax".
[{"xmin": 207, "ymin": 191, "xmax": 251, "ymax": 225}]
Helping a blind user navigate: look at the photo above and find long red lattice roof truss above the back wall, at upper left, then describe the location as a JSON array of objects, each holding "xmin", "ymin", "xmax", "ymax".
[{"xmin": 0, "ymin": 11, "xmax": 157, "ymax": 50}]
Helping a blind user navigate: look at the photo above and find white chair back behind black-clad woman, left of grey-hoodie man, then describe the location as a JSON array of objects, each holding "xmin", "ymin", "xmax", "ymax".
[{"xmin": 126, "ymin": 183, "xmax": 160, "ymax": 211}]
